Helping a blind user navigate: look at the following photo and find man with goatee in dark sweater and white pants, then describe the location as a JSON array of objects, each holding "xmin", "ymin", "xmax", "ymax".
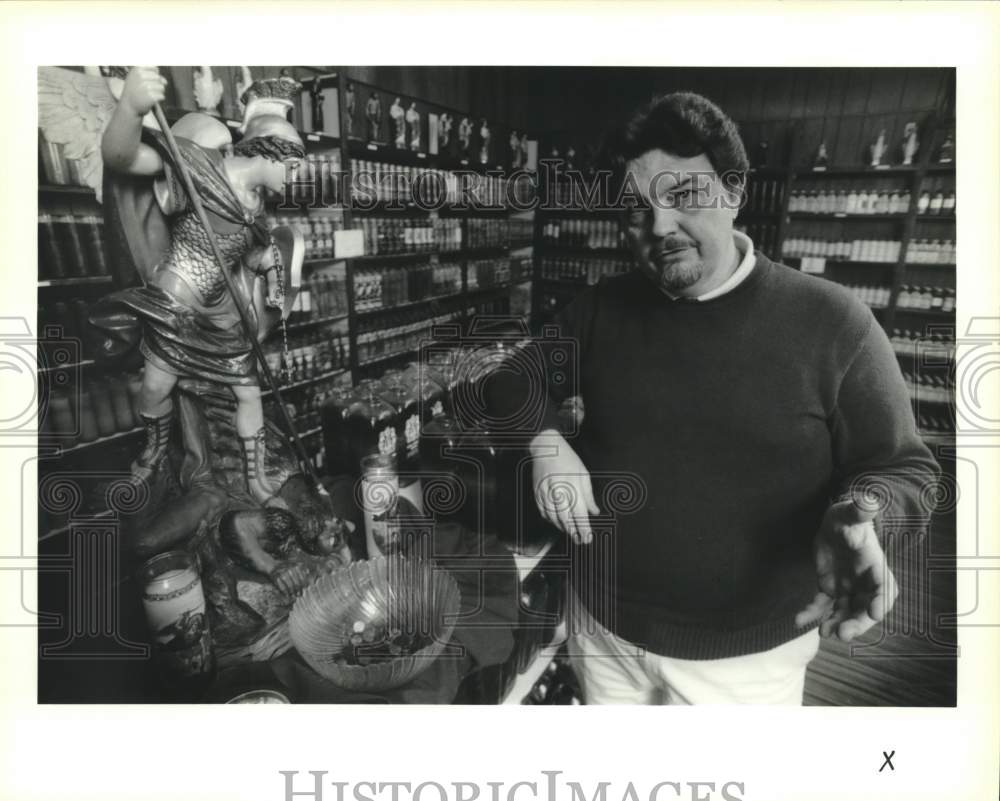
[{"xmin": 499, "ymin": 93, "xmax": 938, "ymax": 704}]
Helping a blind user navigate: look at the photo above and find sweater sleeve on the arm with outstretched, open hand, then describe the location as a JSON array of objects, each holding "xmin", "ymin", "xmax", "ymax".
[{"xmin": 832, "ymin": 319, "xmax": 941, "ymax": 539}]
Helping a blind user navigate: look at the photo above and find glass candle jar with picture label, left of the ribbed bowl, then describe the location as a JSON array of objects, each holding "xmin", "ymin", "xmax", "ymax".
[{"xmin": 139, "ymin": 551, "xmax": 215, "ymax": 690}]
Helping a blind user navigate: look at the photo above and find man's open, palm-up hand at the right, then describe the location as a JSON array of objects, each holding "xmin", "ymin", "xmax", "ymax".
[{"xmin": 795, "ymin": 500, "xmax": 899, "ymax": 642}]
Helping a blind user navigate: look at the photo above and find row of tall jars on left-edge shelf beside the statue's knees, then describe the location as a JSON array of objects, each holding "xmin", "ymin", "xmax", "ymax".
[{"xmin": 39, "ymin": 373, "xmax": 142, "ymax": 446}]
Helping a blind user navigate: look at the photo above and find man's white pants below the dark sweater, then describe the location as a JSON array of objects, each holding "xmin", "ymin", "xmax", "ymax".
[{"xmin": 568, "ymin": 591, "xmax": 819, "ymax": 706}]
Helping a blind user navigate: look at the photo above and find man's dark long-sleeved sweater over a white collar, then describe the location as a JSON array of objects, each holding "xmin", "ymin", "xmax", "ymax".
[{"xmin": 496, "ymin": 253, "xmax": 938, "ymax": 659}]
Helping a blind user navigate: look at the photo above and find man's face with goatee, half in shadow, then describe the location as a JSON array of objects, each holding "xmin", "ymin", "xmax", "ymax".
[{"xmin": 627, "ymin": 150, "xmax": 739, "ymax": 297}]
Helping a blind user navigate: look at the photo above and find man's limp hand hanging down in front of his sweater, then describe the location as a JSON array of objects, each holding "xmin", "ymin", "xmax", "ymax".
[{"xmin": 531, "ymin": 430, "xmax": 600, "ymax": 545}]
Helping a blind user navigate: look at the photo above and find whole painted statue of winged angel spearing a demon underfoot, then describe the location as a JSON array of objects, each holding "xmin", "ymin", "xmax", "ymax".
[{"xmin": 39, "ymin": 67, "xmax": 350, "ymax": 656}]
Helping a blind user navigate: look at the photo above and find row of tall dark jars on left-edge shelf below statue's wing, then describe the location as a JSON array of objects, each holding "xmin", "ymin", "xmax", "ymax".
[{"xmin": 38, "ymin": 212, "xmax": 109, "ymax": 280}]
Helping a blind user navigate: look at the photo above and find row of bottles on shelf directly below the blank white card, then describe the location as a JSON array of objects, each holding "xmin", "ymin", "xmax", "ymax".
[{"xmin": 354, "ymin": 262, "xmax": 462, "ymax": 312}]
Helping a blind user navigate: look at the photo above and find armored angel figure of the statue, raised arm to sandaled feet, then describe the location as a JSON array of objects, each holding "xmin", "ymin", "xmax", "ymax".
[{"xmin": 40, "ymin": 67, "xmax": 304, "ymax": 503}]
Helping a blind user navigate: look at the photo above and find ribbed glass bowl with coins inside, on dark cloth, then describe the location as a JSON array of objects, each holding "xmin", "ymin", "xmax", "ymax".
[{"xmin": 288, "ymin": 556, "xmax": 461, "ymax": 691}]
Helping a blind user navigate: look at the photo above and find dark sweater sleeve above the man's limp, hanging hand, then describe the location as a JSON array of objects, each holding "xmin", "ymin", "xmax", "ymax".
[{"xmin": 487, "ymin": 287, "xmax": 597, "ymax": 440}]
